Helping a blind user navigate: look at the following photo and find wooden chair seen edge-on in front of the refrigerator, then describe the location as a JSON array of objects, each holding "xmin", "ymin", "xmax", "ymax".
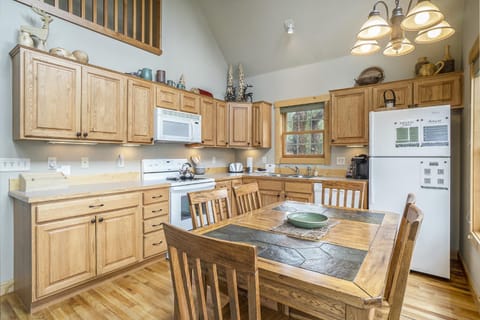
[{"xmin": 376, "ymin": 201, "xmax": 423, "ymax": 320}]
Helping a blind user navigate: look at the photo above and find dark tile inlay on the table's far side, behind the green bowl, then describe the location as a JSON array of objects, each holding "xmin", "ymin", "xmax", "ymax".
[{"xmin": 273, "ymin": 202, "xmax": 385, "ymax": 224}]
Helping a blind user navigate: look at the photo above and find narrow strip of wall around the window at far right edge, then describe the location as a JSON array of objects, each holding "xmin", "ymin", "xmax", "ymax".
[{"xmin": 460, "ymin": 0, "xmax": 480, "ymax": 302}]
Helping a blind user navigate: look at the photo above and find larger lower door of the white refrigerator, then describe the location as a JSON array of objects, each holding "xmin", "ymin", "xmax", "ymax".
[{"xmin": 369, "ymin": 158, "xmax": 450, "ymax": 278}]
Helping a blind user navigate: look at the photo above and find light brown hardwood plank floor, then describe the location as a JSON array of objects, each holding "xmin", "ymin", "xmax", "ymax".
[{"xmin": 0, "ymin": 261, "xmax": 480, "ymax": 320}]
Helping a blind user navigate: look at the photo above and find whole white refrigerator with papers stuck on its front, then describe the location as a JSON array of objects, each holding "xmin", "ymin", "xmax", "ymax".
[{"xmin": 368, "ymin": 106, "xmax": 451, "ymax": 278}]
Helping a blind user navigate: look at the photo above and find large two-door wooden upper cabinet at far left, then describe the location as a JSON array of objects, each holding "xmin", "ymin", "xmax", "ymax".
[{"xmin": 10, "ymin": 47, "xmax": 126, "ymax": 142}]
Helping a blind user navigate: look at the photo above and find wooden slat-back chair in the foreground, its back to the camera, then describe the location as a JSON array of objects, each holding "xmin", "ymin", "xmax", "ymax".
[{"xmin": 163, "ymin": 223, "xmax": 287, "ymax": 320}]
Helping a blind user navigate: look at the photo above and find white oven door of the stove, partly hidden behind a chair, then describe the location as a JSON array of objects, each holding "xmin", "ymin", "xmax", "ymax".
[{"xmin": 170, "ymin": 182, "xmax": 215, "ymax": 230}]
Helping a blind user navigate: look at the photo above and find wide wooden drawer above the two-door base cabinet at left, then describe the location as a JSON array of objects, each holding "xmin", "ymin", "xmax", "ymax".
[{"xmin": 35, "ymin": 193, "xmax": 140, "ymax": 223}]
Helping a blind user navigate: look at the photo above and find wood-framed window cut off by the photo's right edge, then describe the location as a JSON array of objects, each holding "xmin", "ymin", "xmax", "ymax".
[{"xmin": 469, "ymin": 38, "xmax": 480, "ymax": 242}]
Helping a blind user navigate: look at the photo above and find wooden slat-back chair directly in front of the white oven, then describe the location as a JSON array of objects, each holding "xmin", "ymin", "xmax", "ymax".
[{"xmin": 188, "ymin": 189, "xmax": 232, "ymax": 230}]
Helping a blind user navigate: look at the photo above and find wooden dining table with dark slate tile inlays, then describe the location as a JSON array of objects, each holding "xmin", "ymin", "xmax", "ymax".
[{"xmin": 193, "ymin": 201, "xmax": 399, "ymax": 320}]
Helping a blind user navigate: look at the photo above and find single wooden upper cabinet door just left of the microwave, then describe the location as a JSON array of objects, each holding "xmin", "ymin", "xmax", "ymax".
[{"xmin": 127, "ymin": 80, "xmax": 155, "ymax": 143}]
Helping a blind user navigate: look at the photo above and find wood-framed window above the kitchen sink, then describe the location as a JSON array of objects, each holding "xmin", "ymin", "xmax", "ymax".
[{"xmin": 275, "ymin": 95, "xmax": 330, "ymax": 164}]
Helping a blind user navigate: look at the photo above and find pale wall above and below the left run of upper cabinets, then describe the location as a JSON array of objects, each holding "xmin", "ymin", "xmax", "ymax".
[{"xmin": 0, "ymin": 0, "xmax": 231, "ymax": 284}]
